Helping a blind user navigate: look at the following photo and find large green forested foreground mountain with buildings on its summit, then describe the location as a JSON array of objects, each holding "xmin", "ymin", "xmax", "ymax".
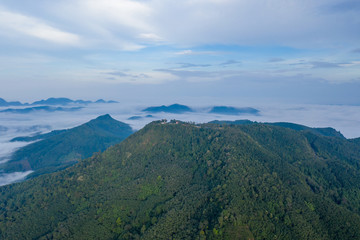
[{"xmin": 0, "ymin": 121, "xmax": 360, "ymax": 240}]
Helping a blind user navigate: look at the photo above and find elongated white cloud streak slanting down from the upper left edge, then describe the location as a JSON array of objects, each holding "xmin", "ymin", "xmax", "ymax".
[{"xmin": 0, "ymin": 8, "xmax": 80, "ymax": 45}]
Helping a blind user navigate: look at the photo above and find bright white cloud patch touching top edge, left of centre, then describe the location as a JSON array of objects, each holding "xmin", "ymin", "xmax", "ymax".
[{"xmin": 48, "ymin": 0, "xmax": 155, "ymax": 51}]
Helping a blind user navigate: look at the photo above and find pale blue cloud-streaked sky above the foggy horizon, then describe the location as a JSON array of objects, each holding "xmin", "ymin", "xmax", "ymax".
[{"xmin": 0, "ymin": 0, "xmax": 360, "ymax": 105}]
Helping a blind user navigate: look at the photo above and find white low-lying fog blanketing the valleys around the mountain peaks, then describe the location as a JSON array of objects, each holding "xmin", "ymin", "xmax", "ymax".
[{"xmin": 0, "ymin": 103, "xmax": 360, "ymax": 186}]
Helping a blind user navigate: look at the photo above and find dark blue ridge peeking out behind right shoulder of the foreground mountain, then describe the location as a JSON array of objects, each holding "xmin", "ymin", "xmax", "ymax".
[{"xmin": 210, "ymin": 120, "xmax": 345, "ymax": 139}]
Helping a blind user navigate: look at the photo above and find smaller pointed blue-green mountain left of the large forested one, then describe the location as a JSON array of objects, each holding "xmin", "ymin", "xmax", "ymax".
[{"xmin": 0, "ymin": 115, "xmax": 133, "ymax": 176}]
